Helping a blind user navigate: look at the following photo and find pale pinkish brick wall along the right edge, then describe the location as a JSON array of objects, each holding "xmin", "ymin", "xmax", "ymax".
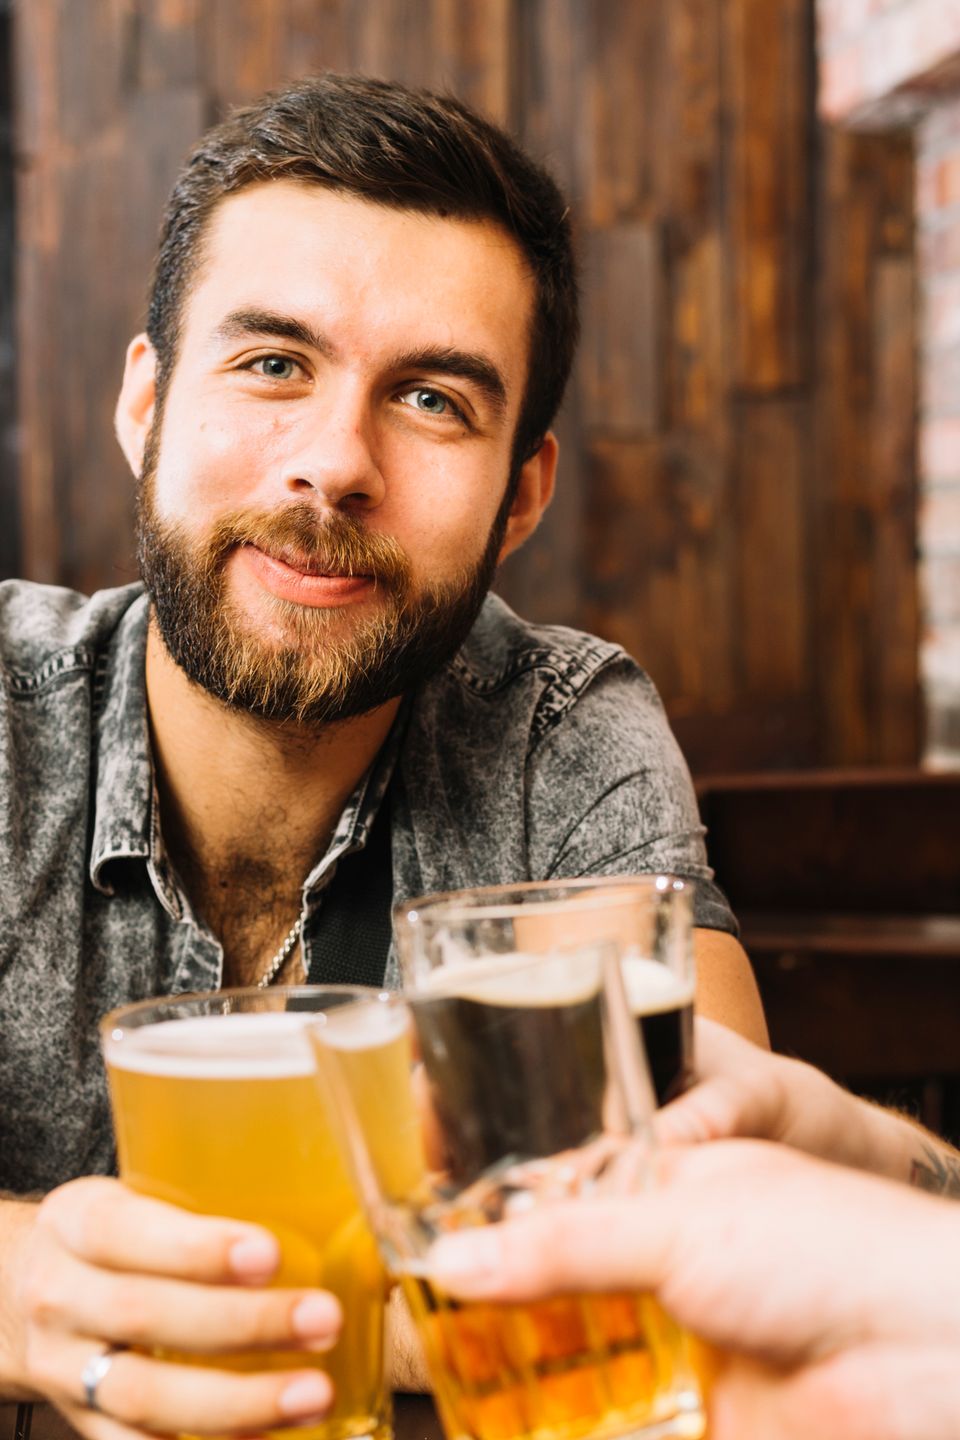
[{"xmin": 818, "ymin": 0, "xmax": 960, "ymax": 766}]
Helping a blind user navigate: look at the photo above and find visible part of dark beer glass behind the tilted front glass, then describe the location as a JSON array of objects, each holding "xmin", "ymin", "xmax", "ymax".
[{"xmin": 394, "ymin": 876, "xmax": 695, "ymax": 1104}]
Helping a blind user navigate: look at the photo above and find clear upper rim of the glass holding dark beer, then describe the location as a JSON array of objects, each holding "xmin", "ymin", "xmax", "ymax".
[{"xmin": 393, "ymin": 871, "xmax": 694, "ymax": 924}]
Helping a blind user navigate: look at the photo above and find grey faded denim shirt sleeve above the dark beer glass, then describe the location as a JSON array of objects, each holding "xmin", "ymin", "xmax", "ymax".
[{"xmin": 527, "ymin": 655, "xmax": 738, "ymax": 935}]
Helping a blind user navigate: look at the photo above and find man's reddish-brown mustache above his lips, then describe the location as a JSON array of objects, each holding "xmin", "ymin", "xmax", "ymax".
[{"xmin": 207, "ymin": 503, "xmax": 410, "ymax": 593}]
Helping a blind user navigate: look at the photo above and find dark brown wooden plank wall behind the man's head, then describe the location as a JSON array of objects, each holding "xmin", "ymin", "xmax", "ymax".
[{"xmin": 3, "ymin": 0, "xmax": 920, "ymax": 773}]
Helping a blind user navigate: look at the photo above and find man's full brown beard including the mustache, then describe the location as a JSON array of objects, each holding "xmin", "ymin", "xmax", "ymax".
[{"xmin": 137, "ymin": 462, "xmax": 507, "ymax": 730}]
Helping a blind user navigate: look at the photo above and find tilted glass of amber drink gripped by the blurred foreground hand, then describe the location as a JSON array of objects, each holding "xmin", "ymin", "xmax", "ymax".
[{"xmin": 309, "ymin": 945, "xmax": 705, "ymax": 1440}]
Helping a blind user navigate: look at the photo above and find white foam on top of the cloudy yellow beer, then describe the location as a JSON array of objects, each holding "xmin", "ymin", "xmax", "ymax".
[{"xmin": 104, "ymin": 1011, "xmax": 315, "ymax": 1080}]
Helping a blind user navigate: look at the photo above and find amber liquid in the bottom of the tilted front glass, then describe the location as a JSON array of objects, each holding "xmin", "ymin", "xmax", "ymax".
[{"xmin": 403, "ymin": 1276, "xmax": 704, "ymax": 1440}]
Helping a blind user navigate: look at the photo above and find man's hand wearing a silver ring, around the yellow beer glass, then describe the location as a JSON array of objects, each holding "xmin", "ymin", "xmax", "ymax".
[{"xmin": 3, "ymin": 1179, "xmax": 341, "ymax": 1440}]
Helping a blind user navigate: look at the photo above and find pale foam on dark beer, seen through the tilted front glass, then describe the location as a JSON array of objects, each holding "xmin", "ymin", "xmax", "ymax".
[{"xmin": 413, "ymin": 952, "xmax": 600, "ymax": 1009}]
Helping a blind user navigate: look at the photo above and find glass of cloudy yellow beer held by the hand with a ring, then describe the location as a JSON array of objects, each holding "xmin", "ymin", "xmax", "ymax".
[{"xmin": 101, "ymin": 985, "xmax": 391, "ymax": 1440}]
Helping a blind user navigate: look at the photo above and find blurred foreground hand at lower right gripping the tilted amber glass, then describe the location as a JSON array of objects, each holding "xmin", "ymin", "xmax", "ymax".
[{"xmin": 430, "ymin": 1140, "xmax": 960, "ymax": 1440}]
